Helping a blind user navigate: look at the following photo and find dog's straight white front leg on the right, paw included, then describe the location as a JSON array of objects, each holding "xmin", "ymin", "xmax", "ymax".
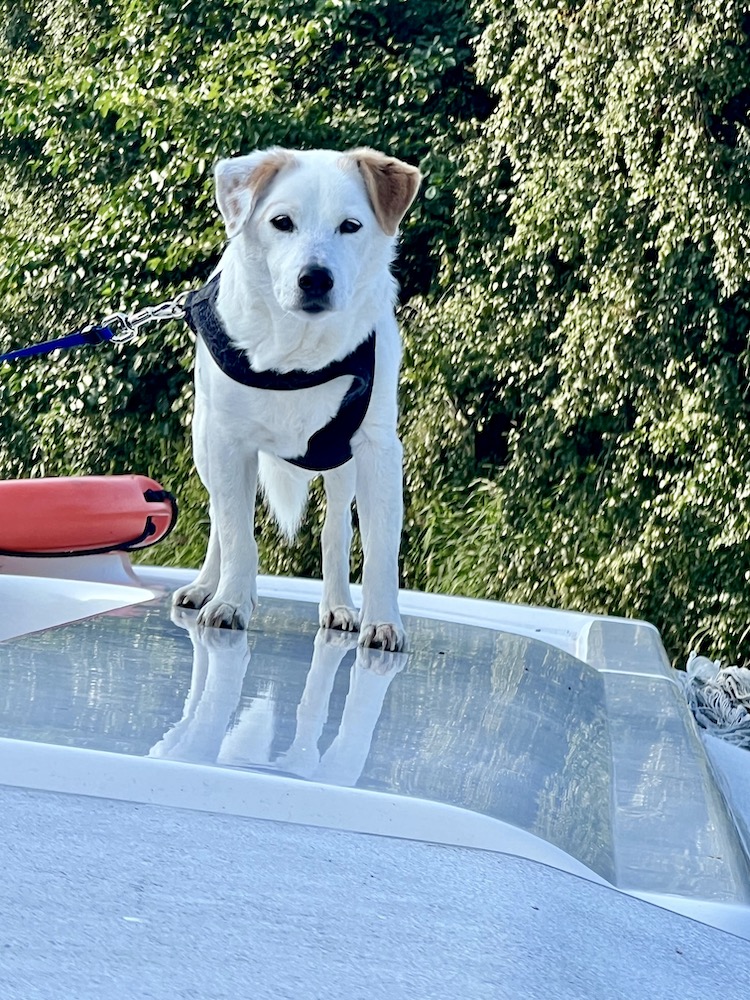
[{"xmin": 352, "ymin": 434, "xmax": 405, "ymax": 650}]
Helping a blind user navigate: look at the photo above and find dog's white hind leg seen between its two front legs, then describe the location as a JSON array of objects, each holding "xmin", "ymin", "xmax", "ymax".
[{"xmin": 320, "ymin": 461, "xmax": 359, "ymax": 632}]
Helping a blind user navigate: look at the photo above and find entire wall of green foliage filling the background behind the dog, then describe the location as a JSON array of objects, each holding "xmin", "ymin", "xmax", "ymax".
[{"xmin": 0, "ymin": 0, "xmax": 750, "ymax": 659}]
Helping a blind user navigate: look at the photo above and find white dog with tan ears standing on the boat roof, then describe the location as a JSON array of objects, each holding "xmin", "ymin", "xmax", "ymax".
[{"xmin": 174, "ymin": 149, "xmax": 421, "ymax": 650}]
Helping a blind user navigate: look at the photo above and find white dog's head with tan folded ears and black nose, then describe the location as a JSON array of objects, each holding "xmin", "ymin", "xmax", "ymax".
[{"xmin": 215, "ymin": 149, "xmax": 421, "ymax": 319}]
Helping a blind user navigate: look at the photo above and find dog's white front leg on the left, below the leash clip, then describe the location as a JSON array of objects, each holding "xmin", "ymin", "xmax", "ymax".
[{"xmin": 197, "ymin": 447, "xmax": 258, "ymax": 629}]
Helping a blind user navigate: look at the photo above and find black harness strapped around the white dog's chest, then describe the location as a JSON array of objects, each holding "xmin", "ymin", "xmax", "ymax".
[{"xmin": 185, "ymin": 274, "xmax": 375, "ymax": 472}]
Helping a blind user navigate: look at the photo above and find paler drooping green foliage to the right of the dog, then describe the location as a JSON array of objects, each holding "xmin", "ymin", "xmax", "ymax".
[{"xmin": 407, "ymin": 0, "xmax": 750, "ymax": 656}]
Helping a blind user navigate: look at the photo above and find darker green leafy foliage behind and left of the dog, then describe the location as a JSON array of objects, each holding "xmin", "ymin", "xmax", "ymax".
[{"xmin": 0, "ymin": 0, "xmax": 474, "ymax": 573}]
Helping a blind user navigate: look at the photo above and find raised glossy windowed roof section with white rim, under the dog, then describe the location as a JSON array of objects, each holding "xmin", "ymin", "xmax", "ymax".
[{"xmin": 0, "ymin": 568, "xmax": 750, "ymax": 936}]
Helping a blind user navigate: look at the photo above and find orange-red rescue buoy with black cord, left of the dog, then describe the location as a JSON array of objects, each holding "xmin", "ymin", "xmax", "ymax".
[{"xmin": 0, "ymin": 475, "xmax": 177, "ymax": 556}]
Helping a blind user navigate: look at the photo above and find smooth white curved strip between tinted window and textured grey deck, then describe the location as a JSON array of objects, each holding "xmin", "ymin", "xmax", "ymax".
[{"xmin": 0, "ymin": 738, "xmax": 606, "ymax": 884}]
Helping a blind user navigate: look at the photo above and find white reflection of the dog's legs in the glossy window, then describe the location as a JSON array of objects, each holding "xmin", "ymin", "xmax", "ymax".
[{"xmin": 149, "ymin": 609, "xmax": 407, "ymax": 786}]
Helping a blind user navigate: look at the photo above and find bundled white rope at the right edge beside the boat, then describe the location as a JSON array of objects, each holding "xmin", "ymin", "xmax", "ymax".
[{"xmin": 676, "ymin": 652, "xmax": 750, "ymax": 750}]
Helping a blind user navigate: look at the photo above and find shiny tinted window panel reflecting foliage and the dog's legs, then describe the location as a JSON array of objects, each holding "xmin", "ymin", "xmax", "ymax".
[{"xmin": 0, "ymin": 598, "xmax": 615, "ymax": 880}]
